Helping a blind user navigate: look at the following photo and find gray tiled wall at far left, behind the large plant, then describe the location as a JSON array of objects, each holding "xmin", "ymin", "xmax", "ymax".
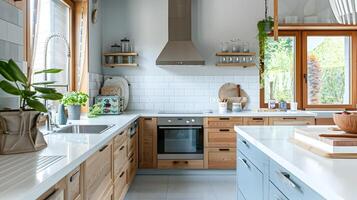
[{"xmin": 0, "ymin": 0, "xmax": 23, "ymax": 110}]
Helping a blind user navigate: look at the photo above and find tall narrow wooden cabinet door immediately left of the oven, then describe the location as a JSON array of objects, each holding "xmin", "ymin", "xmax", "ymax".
[{"xmin": 139, "ymin": 117, "xmax": 157, "ymax": 168}]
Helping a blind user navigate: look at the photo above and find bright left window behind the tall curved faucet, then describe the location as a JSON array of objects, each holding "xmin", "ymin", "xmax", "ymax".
[{"xmin": 30, "ymin": 0, "xmax": 71, "ymax": 92}]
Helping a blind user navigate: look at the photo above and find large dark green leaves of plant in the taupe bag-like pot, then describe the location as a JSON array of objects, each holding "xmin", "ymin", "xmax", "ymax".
[{"xmin": 0, "ymin": 59, "xmax": 63, "ymax": 112}]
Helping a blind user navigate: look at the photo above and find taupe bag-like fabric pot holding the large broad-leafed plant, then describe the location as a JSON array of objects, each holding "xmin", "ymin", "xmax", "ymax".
[{"xmin": 0, "ymin": 110, "xmax": 47, "ymax": 154}]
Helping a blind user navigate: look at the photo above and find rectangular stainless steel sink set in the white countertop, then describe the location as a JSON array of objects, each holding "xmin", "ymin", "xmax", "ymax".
[{"xmin": 54, "ymin": 125, "xmax": 114, "ymax": 134}]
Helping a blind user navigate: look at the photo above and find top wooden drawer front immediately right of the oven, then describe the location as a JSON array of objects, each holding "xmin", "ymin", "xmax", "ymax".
[{"xmin": 205, "ymin": 117, "xmax": 243, "ymax": 128}]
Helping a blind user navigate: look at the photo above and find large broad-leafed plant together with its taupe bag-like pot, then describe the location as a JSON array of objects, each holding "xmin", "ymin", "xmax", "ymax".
[{"xmin": 0, "ymin": 60, "xmax": 63, "ymax": 154}]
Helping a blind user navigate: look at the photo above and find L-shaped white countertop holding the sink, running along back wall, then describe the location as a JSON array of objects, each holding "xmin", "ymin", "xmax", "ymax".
[{"xmin": 0, "ymin": 111, "xmax": 315, "ymax": 200}]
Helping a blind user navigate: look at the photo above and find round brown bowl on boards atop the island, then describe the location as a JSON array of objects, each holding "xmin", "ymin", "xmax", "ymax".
[{"xmin": 333, "ymin": 112, "xmax": 357, "ymax": 134}]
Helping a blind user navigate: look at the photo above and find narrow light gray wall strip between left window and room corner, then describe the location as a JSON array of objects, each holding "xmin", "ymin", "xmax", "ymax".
[{"xmin": 88, "ymin": 0, "xmax": 103, "ymax": 74}]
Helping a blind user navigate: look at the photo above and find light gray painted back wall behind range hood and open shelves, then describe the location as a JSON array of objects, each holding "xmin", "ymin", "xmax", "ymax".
[{"xmin": 102, "ymin": 0, "xmax": 270, "ymax": 75}]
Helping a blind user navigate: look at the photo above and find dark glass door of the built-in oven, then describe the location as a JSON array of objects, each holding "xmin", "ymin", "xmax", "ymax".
[{"xmin": 158, "ymin": 126, "xmax": 203, "ymax": 154}]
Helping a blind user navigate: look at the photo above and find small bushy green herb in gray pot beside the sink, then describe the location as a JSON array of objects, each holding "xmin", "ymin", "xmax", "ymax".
[{"xmin": 61, "ymin": 92, "xmax": 89, "ymax": 120}]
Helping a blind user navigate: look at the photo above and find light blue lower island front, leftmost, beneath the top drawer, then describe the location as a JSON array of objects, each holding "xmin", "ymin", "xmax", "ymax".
[{"xmin": 237, "ymin": 152, "xmax": 264, "ymax": 200}]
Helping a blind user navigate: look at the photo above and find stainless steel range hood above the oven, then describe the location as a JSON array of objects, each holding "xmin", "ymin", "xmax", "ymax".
[{"xmin": 156, "ymin": 0, "xmax": 205, "ymax": 65}]
